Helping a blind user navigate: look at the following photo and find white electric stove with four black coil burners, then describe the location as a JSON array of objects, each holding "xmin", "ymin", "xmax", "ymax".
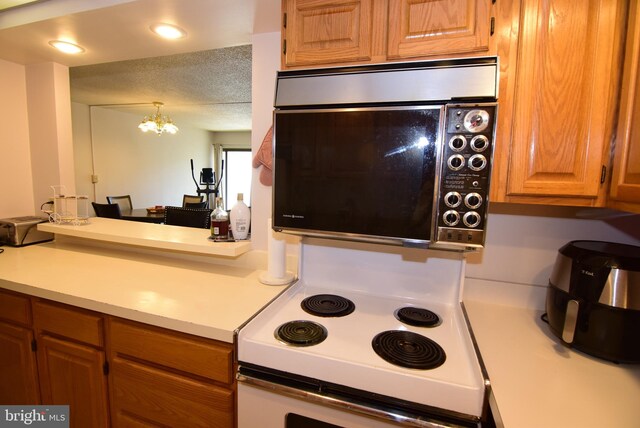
[{"xmin": 238, "ymin": 238, "xmax": 488, "ymax": 428}]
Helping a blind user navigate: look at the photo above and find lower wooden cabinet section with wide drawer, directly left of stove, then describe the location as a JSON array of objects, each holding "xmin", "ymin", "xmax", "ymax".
[{"xmin": 108, "ymin": 319, "xmax": 235, "ymax": 428}]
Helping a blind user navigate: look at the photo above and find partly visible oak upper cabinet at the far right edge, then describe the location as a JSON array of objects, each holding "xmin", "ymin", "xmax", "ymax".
[{"xmin": 608, "ymin": 1, "xmax": 640, "ymax": 212}]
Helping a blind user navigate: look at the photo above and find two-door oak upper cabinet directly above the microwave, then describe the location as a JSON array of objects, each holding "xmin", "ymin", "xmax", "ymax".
[{"xmin": 282, "ymin": 0, "xmax": 492, "ymax": 68}]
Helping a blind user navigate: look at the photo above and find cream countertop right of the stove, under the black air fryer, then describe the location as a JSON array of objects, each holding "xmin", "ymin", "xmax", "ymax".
[{"xmin": 464, "ymin": 279, "xmax": 640, "ymax": 428}]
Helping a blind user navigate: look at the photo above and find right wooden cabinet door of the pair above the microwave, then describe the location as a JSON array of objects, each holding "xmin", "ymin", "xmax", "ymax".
[{"xmin": 387, "ymin": 0, "xmax": 491, "ymax": 59}]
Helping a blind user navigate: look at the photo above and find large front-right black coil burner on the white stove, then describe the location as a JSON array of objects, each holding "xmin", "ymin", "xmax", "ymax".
[{"xmin": 371, "ymin": 330, "xmax": 447, "ymax": 370}]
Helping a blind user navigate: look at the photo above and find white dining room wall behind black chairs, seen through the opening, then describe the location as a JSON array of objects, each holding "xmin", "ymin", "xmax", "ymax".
[{"xmin": 73, "ymin": 104, "xmax": 212, "ymax": 208}]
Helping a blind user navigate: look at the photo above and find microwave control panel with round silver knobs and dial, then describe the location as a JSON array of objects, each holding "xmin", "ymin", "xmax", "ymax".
[{"xmin": 436, "ymin": 103, "xmax": 497, "ymax": 247}]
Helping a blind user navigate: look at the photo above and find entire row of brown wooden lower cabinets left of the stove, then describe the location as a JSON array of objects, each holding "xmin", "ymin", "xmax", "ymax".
[{"xmin": 0, "ymin": 290, "xmax": 236, "ymax": 428}]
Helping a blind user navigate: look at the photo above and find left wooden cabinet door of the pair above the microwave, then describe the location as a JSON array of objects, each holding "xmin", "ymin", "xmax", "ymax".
[{"xmin": 283, "ymin": 0, "xmax": 372, "ymax": 66}]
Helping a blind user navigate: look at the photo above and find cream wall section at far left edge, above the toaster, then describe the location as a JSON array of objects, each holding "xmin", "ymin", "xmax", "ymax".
[{"xmin": 0, "ymin": 60, "xmax": 35, "ymax": 218}]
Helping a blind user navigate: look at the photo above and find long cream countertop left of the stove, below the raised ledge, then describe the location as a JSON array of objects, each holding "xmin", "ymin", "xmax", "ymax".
[{"xmin": 0, "ymin": 239, "xmax": 286, "ymax": 343}]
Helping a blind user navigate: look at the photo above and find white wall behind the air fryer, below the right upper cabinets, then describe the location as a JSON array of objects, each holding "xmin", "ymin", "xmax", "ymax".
[{"xmin": 466, "ymin": 204, "xmax": 640, "ymax": 286}]
